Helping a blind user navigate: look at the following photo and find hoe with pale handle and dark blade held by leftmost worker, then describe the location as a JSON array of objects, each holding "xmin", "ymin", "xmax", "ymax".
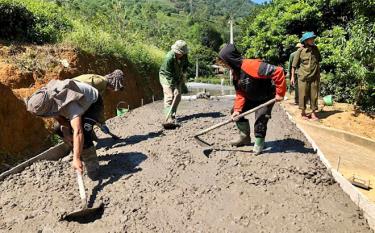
[{"xmin": 64, "ymin": 171, "xmax": 104, "ymax": 223}]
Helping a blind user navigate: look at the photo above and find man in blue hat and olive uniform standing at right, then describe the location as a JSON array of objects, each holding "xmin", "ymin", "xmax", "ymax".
[{"xmin": 290, "ymin": 32, "xmax": 322, "ymax": 120}]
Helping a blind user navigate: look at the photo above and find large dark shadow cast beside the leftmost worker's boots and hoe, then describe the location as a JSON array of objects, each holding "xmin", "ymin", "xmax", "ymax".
[{"xmin": 88, "ymin": 152, "xmax": 147, "ymax": 207}]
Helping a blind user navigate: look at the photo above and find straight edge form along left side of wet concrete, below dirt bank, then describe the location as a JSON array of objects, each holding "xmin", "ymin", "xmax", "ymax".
[{"xmin": 0, "ymin": 143, "xmax": 70, "ymax": 181}]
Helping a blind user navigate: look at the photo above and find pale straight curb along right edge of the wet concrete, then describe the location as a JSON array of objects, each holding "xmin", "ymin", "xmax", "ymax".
[{"xmin": 280, "ymin": 105, "xmax": 375, "ymax": 231}]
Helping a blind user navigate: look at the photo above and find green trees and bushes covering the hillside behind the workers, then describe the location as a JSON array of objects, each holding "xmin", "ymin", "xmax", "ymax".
[{"xmin": 0, "ymin": 0, "xmax": 375, "ymax": 111}]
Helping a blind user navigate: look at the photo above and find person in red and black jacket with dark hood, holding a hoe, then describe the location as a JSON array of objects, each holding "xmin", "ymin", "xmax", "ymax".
[{"xmin": 219, "ymin": 44, "xmax": 286, "ymax": 155}]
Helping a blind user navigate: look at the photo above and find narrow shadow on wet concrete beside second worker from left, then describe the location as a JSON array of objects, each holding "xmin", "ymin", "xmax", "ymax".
[{"xmin": 96, "ymin": 130, "xmax": 163, "ymax": 149}]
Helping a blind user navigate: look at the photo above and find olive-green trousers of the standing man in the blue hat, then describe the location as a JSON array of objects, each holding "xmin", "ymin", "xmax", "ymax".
[{"xmin": 298, "ymin": 78, "xmax": 320, "ymax": 111}]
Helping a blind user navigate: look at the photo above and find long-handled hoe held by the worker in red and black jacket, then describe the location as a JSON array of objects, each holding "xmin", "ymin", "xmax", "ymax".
[{"xmin": 194, "ymin": 99, "xmax": 276, "ymax": 157}]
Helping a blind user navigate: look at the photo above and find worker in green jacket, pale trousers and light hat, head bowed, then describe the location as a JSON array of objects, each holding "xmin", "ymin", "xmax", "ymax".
[{"xmin": 159, "ymin": 40, "xmax": 188, "ymax": 121}]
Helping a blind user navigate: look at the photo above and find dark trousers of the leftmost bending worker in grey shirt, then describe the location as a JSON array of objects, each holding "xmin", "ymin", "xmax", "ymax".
[{"xmin": 53, "ymin": 95, "xmax": 104, "ymax": 149}]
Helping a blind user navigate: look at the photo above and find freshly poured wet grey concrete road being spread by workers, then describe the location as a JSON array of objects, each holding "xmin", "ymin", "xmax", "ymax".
[{"xmin": 0, "ymin": 100, "xmax": 372, "ymax": 233}]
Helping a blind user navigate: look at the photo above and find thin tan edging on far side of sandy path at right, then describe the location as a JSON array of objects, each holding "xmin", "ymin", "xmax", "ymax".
[{"xmin": 298, "ymin": 122, "xmax": 375, "ymax": 151}]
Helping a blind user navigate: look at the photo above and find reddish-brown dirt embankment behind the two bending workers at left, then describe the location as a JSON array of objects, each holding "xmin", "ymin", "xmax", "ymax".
[{"xmin": 0, "ymin": 44, "xmax": 162, "ymax": 171}]
